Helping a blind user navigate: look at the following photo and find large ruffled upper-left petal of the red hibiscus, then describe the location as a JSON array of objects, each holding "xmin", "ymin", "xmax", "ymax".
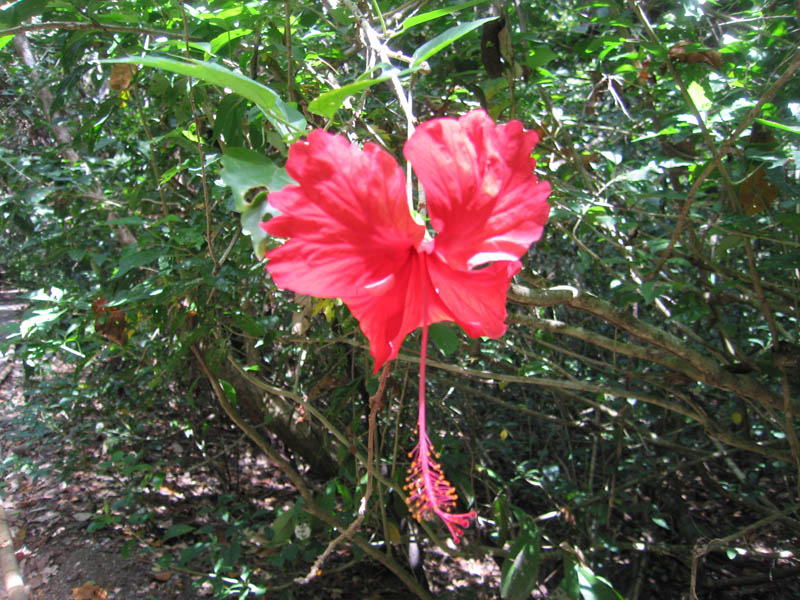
[{"xmin": 261, "ymin": 130, "xmax": 425, "ymax": 298}]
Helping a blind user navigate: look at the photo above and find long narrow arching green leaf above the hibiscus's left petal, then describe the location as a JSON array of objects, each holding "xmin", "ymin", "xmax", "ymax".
[{"xmin": 101, "ymin": 55, "xmax": 306, "ymax": 141}]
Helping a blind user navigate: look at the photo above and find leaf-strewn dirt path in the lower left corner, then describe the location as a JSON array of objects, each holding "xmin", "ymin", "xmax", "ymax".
[{"xmin": 0, "ymin": 290, "xmax": 194, "ymax": 600}]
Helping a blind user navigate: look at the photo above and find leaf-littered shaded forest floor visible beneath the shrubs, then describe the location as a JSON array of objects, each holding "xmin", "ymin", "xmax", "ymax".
[{"xmin": 6, "ymin": 282, "xmax": 800, "ymax": 600}]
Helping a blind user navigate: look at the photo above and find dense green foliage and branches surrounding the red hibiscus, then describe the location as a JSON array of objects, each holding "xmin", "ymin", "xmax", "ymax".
[{"xmin": 0, "ymin": 0, "xmax": 800, "ymax": 598}]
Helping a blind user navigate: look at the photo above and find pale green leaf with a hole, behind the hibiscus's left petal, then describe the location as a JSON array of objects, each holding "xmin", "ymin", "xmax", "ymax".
[{"xmin": 222, "ymin": 148, "xmax": 294, "ymax": 258}]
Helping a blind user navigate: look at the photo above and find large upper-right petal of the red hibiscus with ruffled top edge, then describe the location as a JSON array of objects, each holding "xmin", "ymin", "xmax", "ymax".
[{"xmin": 404, "ymin": 110, "xmax": 550, "ymax": 269}]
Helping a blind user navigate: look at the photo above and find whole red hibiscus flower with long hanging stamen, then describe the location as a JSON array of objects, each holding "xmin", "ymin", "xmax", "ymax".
[{"xmin": 261, "ymin": 110, "xmax": 550, "ymax": 542}]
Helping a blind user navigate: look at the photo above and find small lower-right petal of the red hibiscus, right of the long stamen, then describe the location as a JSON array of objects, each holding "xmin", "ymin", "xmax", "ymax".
[{"xmin": 428, "ymin": 258, "xmax": 521, "ymax": 337}]
